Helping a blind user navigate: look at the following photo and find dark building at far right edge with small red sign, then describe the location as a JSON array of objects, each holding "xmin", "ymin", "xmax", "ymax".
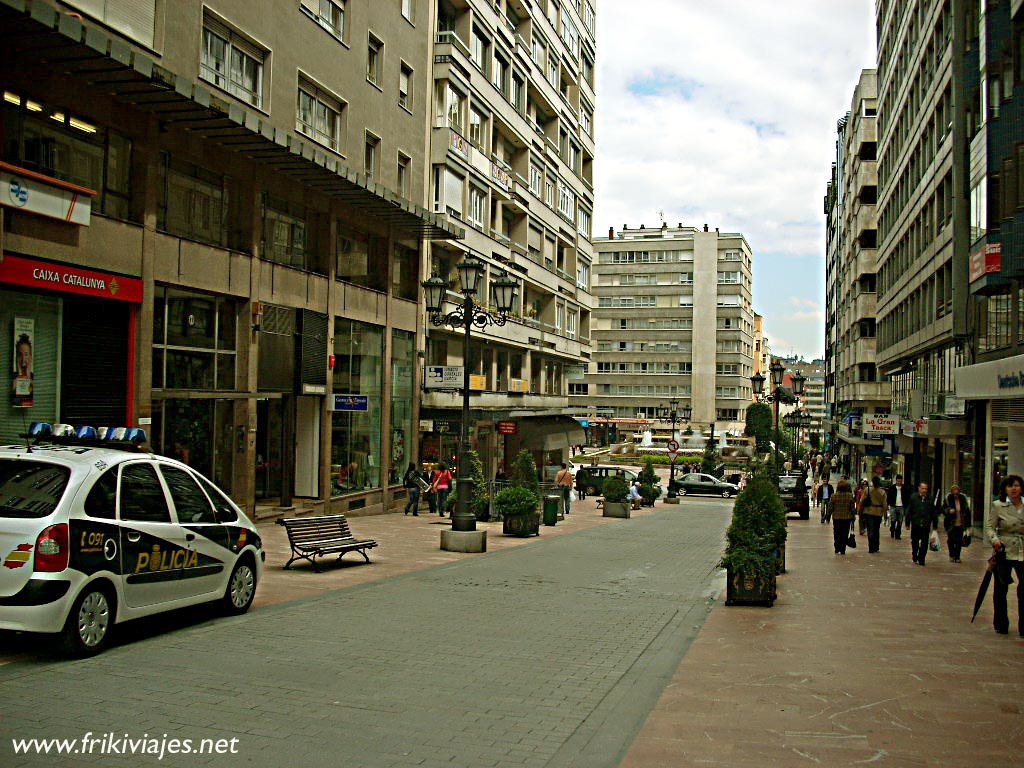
[{"xmin": 945, "ymin": 1, "xmax": 1024, "ymax": 500}]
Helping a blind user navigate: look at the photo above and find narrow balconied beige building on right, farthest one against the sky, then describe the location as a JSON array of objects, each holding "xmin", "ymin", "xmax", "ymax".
[{"xmin": 823, "ymin": 70, "xmax": 890, "ymax": 467}]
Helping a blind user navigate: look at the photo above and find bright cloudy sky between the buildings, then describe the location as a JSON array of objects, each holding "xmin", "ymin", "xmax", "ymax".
[{"xmin": 594, "ymin": 0, "xmax": 874, "ymax": 359}]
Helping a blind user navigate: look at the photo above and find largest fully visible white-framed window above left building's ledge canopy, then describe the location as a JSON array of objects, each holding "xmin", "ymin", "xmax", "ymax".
[{"xmin": 200, "ymin": 14, "xmax": 266, "ymax": 108}]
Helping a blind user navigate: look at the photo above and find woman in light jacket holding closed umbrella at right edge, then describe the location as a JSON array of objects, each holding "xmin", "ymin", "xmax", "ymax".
[{"xmin": 985, "ymin": 475, "xmax": 1024, "ymax": 637}]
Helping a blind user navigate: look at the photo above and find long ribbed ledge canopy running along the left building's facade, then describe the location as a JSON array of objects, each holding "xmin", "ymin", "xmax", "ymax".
[{"xmin": 0, "ymin": 0, "xmax": 465, "ymax": 240}]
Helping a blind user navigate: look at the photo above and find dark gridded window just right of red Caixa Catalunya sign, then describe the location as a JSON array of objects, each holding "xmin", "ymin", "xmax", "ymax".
[{"xmin": 153, "ymin": 286, "xmax": 239, "ymax": 390}]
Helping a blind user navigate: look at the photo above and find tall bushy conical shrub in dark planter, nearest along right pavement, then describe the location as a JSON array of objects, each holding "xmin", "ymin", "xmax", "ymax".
[{"xmin": 719, "ymin": 472, "xmax": 786, "ymax": 606}]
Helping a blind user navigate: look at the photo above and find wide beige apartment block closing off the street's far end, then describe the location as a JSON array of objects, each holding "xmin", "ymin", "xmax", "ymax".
[{"xmin": 570, "ymin": 223, "xmax": 755, "ymax": 434}]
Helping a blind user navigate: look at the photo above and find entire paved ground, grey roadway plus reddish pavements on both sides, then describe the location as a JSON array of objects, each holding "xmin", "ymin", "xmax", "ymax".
[{"xmin": 0, "ymin": 489, "xmax": 1024, "ymax": 768}]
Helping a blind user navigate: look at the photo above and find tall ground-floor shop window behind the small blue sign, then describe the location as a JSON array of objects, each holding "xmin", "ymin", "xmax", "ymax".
[{"xmin": 331, "ymin": 317, "xmax": 384, "ymax": 496}]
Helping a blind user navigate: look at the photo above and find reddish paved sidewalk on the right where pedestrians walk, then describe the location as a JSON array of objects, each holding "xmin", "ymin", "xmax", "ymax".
[{"xmin": 622, "ymin": 509, "xmax": 1024, "ymax": 768}]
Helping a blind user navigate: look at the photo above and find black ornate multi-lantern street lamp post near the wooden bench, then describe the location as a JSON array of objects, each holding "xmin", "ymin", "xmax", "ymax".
[{"xmin": 421, "ymin": 256, "xmax": 519, "ymax": 530}]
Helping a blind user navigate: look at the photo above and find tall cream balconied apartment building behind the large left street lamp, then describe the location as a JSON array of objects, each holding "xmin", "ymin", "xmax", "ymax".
[{"xmin": 420, "ymin": 0, "xmax": 596, "ymax": 476}]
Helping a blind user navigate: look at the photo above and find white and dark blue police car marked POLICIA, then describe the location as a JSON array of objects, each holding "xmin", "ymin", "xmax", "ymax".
[{"xmin": 0, "ymin": 422, "xmax": 265, "ymax": 655}]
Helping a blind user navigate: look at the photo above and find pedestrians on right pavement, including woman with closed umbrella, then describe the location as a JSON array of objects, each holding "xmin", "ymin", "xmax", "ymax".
[{"xmin": 818, "ymin": 474, "xmax": 1024, "ymax": 637}]
